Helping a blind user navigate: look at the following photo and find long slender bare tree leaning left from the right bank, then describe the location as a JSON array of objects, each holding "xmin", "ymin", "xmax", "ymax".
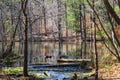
[{"xmin": 87, "ymin": 0, "xmax": 120, "ymax": 62}]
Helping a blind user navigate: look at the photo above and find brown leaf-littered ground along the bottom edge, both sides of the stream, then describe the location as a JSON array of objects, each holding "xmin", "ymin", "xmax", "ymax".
[{"xmin": 0, "ymin": 63, "xmax": 120, "ymax": 80}]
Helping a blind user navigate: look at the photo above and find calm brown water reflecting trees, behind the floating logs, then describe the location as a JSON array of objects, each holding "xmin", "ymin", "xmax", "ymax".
[{"xmin": 11, "ymin": 42, "xmax": 92, "ymax": 66}]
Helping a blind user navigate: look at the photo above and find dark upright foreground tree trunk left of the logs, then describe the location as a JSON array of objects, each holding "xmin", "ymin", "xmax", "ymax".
[{"xmin": 21, "ymin": 0, "xmax": 28, "ymax": 77}]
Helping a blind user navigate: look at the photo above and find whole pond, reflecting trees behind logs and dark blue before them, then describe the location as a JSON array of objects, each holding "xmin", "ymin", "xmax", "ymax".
[{"xmin": 0, "ymin": 42, "xmax": 105, "ymax": 79}]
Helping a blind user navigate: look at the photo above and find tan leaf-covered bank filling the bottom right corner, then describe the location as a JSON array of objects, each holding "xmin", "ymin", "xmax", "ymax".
[{"xmin": 99, "ymin": 63, "xmax": 120, "ymax": 80}]
